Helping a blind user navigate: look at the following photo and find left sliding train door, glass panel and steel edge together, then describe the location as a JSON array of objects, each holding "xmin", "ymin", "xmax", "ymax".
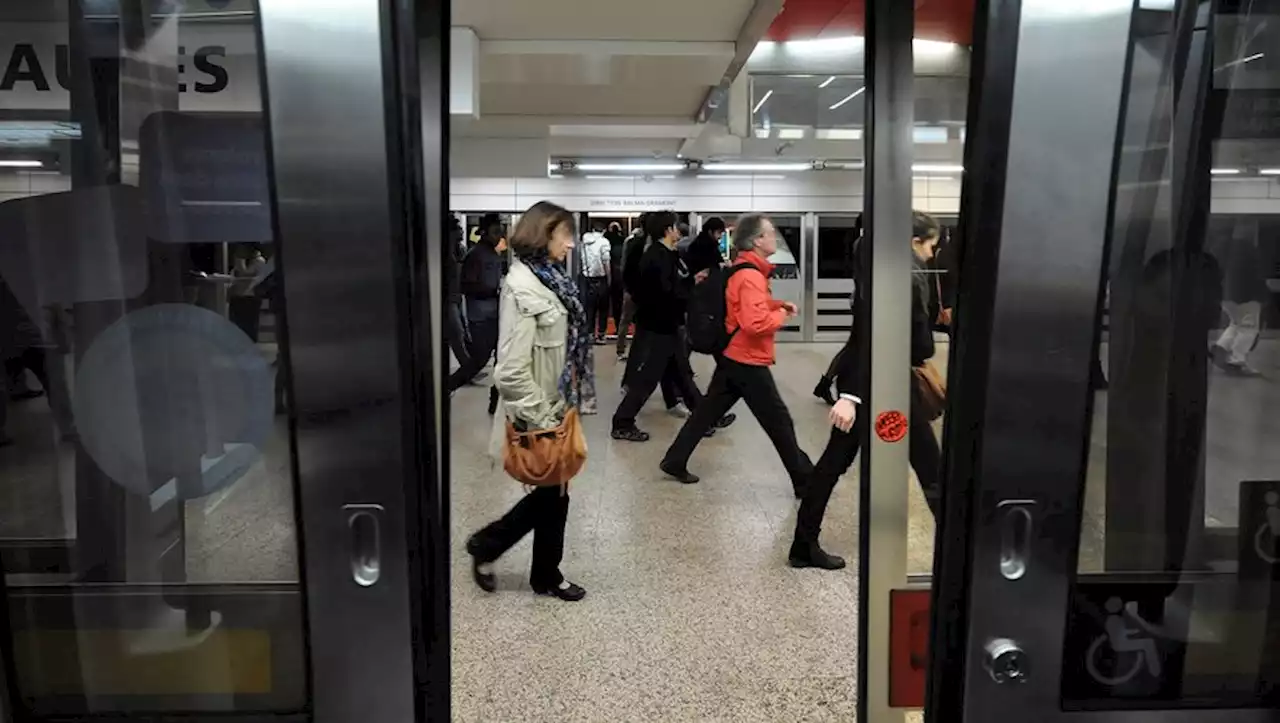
[{"xmin": 0, "ymin": 0, "xmax": 448, "ymax": 722}]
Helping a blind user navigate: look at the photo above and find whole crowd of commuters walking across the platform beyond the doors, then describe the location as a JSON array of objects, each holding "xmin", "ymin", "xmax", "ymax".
[{"xmin": 449, "ymin": 202, "xmax": 950, "ymax": 600}]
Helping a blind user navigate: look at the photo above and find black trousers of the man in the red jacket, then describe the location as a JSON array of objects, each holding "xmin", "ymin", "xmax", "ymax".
[{"xmin": 663, "ymin": 357, "xmax": 813, "ymax": 491}]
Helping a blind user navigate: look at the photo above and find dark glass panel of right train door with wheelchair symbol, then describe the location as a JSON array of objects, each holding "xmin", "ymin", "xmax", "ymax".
[{"xmin": 1062, "ymin": 3, "xmax": 1280, "ymax": 709}]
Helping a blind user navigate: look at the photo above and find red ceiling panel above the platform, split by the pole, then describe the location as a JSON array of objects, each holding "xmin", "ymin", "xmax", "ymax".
[{"xmin": 765, "ymin": 0, "xmax": 975, "ymax": 45}]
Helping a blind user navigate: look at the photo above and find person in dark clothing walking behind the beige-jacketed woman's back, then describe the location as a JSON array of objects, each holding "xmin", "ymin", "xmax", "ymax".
[{"xmin": 449, "ymin": 214, "xmax": 503, "ymax": 392}]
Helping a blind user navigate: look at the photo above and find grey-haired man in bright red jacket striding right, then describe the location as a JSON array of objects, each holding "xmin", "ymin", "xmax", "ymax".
[{"xmin": 659, "ymin": 214, "xmax": 813, "ymax": 498}]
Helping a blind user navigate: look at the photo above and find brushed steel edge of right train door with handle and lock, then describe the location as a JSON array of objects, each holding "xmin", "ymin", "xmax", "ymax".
[{"xmin": 925, "ymin": 0, "xmax": 1275, "ymax": 723}]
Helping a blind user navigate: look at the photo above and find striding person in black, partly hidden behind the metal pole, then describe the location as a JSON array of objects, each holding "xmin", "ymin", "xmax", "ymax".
[{"xmin": 788, "ymin": 211, "xmax": 942, "ymax": 569}]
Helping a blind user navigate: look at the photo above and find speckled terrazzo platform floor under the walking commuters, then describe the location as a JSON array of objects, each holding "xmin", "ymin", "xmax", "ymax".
[{"xmin": 452, "ymin": 344, "xmax": 932, "ymax": 722}]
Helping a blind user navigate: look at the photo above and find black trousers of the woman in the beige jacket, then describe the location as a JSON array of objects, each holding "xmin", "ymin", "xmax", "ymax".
[{"xmin": 472, "ymin": 486, "xmax": 568, "ymax": 587}]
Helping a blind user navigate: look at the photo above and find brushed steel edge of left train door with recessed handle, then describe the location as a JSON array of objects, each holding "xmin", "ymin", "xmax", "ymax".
[{"xmin": 257, "ymin": 0, "xmax": 449, "ymax": 722}]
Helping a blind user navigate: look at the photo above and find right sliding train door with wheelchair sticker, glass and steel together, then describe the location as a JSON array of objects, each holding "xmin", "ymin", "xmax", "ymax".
[{"xmin": 927, "ymin": 0, "xmax": 1280, "ymax": 723}]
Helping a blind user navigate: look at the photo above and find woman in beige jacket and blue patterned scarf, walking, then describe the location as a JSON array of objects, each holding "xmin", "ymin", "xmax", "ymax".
[{"xmin": 467, "ymin": 201, "xmax": 593, "ymax": 601}]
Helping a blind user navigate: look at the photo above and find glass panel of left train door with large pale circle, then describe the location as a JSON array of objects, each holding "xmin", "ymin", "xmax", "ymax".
[{"xmin": 0, "ymin": 4, "xmax": 306, "ymax": 719}]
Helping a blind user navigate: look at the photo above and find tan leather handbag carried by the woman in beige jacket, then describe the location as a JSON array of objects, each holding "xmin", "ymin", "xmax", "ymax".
[{"xmin": 502, "ymin": 409, "xmax": 586, "ymax": 488}]
